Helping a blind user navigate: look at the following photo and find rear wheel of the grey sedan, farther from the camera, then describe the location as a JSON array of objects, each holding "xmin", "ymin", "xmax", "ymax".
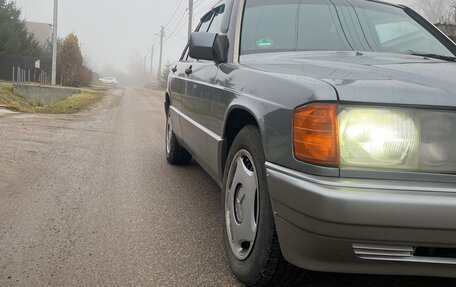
[{"xmin": 165, "ymin": 112, "xmax": 192, "ymax": 165}]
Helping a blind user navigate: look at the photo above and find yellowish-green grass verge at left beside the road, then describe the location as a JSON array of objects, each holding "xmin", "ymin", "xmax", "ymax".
[{"xmin": 0, "ymin": 82, "xmax": 103, "ymax": 114}]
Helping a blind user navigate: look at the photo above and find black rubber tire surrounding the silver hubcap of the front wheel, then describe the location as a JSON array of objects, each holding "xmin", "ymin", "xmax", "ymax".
[{"xmin": 222, "ymin": 126, "xmax": 304, "ymax": 286}]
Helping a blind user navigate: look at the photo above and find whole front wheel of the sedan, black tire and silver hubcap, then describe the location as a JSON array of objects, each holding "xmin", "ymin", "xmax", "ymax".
[{"xmin": 222, "ymin": 126, "xmax": 303, "ymax": 286}]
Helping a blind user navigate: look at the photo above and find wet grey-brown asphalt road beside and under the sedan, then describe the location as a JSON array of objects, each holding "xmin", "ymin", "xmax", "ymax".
[{"xmin": 0, "ymin": 89, "xmax": 456, "ymax": 287}]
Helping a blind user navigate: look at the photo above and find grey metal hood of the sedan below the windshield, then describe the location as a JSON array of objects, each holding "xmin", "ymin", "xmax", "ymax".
[{"xmin": 241, "ymin": 52, "xmax": 456, "ymax": 107}]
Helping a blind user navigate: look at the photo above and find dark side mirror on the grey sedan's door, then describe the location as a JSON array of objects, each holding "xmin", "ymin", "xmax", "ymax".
[{"xmin": 189, "ymin": 32, "xmax": 229, "ymax": 63}]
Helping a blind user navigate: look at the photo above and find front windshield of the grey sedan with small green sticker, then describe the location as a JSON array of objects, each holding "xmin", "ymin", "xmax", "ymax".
[{"xmin": 241, "ymin": 0, "xmax": 454, "ymax": 56}]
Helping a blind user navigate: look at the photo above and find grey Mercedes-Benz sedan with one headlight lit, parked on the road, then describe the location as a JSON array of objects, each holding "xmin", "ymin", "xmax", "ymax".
[{"xmin": 165, "ymin": 0, "xmax": 456, "ymax": 286}]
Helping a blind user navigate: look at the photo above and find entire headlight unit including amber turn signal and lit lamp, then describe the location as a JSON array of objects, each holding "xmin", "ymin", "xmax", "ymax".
[{"xmin": 293, "ymin": 103, "xmax": 456, "ymax": 173}]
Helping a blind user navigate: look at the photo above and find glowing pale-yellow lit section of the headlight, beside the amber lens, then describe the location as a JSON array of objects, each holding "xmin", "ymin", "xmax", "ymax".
[{"xmin": 339, "ymin": 108, "xmax": 420, "ymax": 169}]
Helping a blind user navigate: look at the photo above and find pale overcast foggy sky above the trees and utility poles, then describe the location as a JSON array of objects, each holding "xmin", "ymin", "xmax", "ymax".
[{"xmin": 13, "ymin": 0, "xmax": 412, "ymax": 75}]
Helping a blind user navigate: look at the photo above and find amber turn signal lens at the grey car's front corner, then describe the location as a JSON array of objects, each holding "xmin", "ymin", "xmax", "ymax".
[{"xmin": 293, "ymin": 103, "xmax": 340, "ymax": 166}]
